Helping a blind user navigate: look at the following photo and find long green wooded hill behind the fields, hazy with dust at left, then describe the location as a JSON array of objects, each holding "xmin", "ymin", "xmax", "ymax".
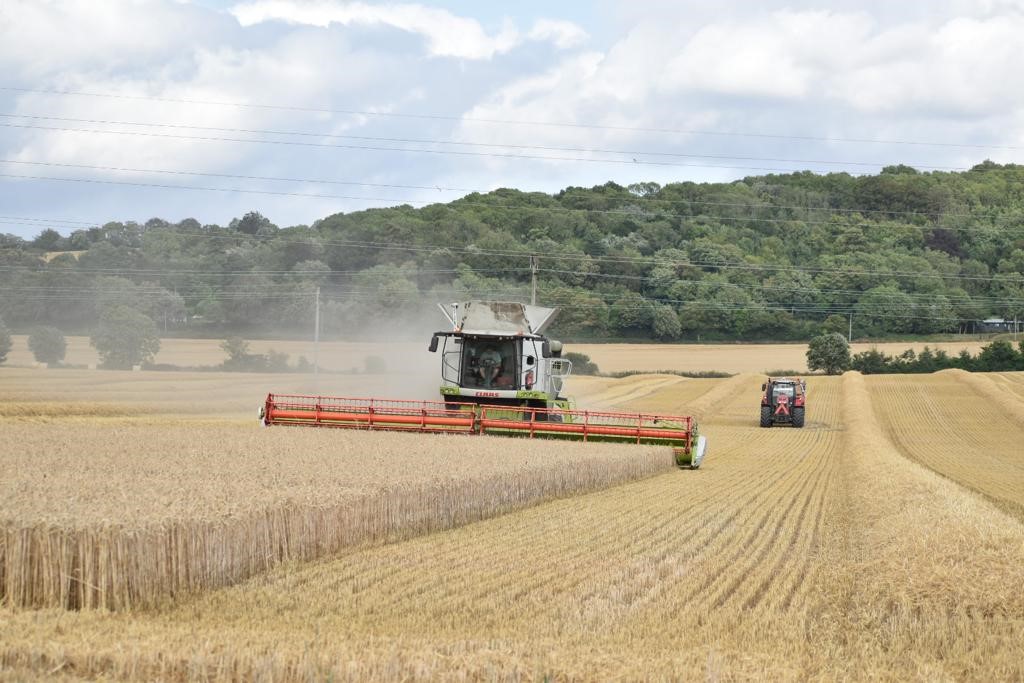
[{"xmin": 0, "ymin": 162, "xmax": 1024, "ymax": 341}]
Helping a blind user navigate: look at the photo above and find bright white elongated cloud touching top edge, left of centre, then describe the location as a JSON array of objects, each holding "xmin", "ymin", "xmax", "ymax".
[{"xmin": 230, "ymin": 0, "xmax": 520, "ymax": 59}]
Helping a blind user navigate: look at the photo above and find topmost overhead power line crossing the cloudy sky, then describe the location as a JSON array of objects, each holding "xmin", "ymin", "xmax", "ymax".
[{"xmin": 0, "ymin": 86, "xmax": 1024, "ymax": 151}]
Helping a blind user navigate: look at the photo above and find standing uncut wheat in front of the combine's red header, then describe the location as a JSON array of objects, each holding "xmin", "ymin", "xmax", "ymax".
[{"xmin": 0, "ymin": 421, "xmax": 673, "ymax": 609}]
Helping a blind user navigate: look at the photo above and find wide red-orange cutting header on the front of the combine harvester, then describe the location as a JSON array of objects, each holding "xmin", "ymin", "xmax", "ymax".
[{"xmin": 261, "ymin": 394, "xmax": 707, "ymax": 469}]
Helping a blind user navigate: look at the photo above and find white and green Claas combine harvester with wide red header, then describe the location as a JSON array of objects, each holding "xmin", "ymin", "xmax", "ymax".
[{"xmin": 260, "ymin": 301, "xmax": 708, "ymax": 469}]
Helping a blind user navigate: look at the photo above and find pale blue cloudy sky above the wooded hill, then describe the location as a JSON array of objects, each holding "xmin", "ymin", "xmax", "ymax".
[{"xmin": 0, "ymin": 0, "xmax": 1024, "ymax": 238}]
